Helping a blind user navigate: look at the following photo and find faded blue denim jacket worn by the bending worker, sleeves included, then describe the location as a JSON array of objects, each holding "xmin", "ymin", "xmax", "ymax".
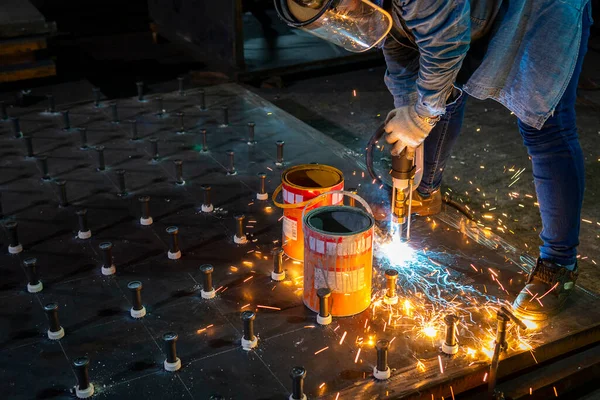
[{"xmin": 382, "ymin": 0, "xmax": 591, "ymax": 129}]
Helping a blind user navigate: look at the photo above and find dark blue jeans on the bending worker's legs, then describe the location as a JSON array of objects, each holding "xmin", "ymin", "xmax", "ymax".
[{"xmin": 418, "ymin": 7, "xmax": 591, "ymax": 265}]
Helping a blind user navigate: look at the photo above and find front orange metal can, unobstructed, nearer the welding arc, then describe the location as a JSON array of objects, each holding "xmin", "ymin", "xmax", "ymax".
[{"xmin": 303, "ymin": 206, "xmax": 375, "ymax": 317}]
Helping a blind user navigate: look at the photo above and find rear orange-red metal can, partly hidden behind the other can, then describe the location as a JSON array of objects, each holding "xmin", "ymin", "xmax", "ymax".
[{"xmin": 272, "ymin": 164, "xmax": 344, "ymax": 261}]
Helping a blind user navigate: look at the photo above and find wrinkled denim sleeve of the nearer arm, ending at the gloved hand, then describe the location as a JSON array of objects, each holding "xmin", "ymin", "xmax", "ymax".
[{"xmin": 396, "ymin": 0, "xmax": 471, "ymax": 116}]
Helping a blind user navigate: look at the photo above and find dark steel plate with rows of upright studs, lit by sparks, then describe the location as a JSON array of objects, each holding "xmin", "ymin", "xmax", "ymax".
[{"xmin": 0, "ymin": 84, "xmax": 600, "ymax": 399}]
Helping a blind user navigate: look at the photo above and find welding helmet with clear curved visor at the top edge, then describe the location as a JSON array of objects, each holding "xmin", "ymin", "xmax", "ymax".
[{"xmin": 275, "ymin": 0, "xmax": 392, "ymax": 53}]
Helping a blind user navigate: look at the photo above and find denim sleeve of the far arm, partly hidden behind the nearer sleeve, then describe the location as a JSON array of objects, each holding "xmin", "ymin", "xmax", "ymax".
[{"xmin": 383, "ymin": 36, "xmax": 419, "ymax": 108}]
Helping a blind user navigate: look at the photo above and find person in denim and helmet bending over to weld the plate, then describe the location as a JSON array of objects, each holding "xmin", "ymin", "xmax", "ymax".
[{"xmin": 275, "ymin": 0, "xmax": 592, "ymax": 320}]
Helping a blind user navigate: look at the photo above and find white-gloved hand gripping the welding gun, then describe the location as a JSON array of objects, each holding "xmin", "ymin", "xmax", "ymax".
[{"xmin": 384, "ymin": 105, "xmax": 433, "ymax": 160}]
